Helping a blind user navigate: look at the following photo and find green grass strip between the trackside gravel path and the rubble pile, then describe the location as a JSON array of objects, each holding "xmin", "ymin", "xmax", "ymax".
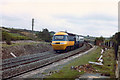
[{"xmin": 46, "ymin": 47, "xmax": 101, "ymax": 78}]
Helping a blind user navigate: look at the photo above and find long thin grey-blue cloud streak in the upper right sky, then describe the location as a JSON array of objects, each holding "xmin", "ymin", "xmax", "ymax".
[{"xmin": 55, "ymin": 13, "xmax": 117, "ymax": 21}]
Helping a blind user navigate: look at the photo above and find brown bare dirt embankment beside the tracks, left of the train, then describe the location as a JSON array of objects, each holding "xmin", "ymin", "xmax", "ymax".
[{"xmin": 2, "ymin": 43, "xmax": 52, "ymax": 59}]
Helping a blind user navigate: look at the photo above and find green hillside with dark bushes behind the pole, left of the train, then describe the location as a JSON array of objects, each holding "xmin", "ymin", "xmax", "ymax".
[{"xmin": 1, "ymin": 27, "xmax": 55, "ymax": 43}]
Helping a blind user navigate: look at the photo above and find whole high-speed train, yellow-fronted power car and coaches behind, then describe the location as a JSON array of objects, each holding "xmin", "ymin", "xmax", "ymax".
[{"xmin": 51, "ymin": 32, "xmax": 84, "ymax": 52}]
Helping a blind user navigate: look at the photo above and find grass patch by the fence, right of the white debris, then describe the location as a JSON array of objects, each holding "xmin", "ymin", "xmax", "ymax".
[{"xmin": 93, "ymin": 49, "xmax": 115, "ymax": 78}]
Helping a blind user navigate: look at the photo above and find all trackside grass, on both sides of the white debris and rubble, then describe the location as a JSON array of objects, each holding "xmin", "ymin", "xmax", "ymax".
[{"xmin": 46, "ymin": 47, "xmax": 115, "ymax": 78}]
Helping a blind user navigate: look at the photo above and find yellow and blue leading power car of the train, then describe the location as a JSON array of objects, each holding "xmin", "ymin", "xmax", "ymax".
[{"xmin": 52, "ymin": 32, "xmax": 74, "ymax": 51}]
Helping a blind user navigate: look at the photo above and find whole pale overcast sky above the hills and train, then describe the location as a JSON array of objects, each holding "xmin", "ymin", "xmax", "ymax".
[{"xmin": 0, "ymin": 0, "xmax": 118, "ymax": 37}]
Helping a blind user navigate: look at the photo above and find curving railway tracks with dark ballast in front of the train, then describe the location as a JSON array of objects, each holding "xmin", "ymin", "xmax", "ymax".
[{"xmin": 1, "ymin": 44, "xmax": 90, "ymax": 79}]
